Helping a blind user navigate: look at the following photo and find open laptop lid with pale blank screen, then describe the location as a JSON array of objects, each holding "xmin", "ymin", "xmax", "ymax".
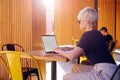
[{"xmin": 41, "ymin": 35, "xmax": 58, "ymax": 53}]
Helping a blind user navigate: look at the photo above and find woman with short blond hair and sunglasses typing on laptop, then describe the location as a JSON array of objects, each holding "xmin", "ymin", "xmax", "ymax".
[{"xmin": 54, "ymin": 7, "xmax": 117, "ymax": 80}]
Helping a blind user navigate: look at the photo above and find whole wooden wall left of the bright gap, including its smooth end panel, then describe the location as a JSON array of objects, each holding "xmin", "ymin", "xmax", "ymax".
[{"xmin": 0, "ymin": 0, "xmax": 46, "ymax": 80}]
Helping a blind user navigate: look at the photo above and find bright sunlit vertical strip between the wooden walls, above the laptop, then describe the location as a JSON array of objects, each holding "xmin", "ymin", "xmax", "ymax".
[{"xmin": 42, "ymin": 0, "xmax": 54, "ymax": 34}]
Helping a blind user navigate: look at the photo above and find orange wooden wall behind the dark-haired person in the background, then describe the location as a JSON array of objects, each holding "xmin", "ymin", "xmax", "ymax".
[{"xmin": 98, "ymin": 0, "xmax": 120, "ymax": 47}]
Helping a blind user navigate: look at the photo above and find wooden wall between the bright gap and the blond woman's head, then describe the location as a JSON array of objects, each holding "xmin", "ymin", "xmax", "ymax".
[{"xmin": 54, "ymin": 0, "xmax": 94, "ymax": 45}]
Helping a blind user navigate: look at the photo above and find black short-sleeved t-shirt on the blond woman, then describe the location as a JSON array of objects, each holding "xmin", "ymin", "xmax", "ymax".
[{"xmin": 77, "ymin": 30, "xmax": 115, "ymax": 64}]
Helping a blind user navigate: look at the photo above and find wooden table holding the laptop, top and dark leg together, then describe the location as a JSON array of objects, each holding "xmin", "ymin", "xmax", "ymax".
[{"xmin": 30, "ymin": 50, "xmax": 68, "ymax": 80}]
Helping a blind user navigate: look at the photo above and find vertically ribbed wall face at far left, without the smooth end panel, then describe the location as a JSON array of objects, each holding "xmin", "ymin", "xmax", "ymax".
[{"xmin": 0, "ymin": 0, "xmax": 32, "ymax": 51}]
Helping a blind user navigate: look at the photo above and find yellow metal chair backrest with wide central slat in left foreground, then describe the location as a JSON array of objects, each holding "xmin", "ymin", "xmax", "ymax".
[{"xmin": 0, "ymin": 51, "xmax": 43, "ymax": 80}]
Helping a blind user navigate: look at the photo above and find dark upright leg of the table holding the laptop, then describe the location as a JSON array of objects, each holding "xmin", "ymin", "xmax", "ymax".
[{"xmin": 51, "ymin": 61, "xmax": 57, "ymax": 80}]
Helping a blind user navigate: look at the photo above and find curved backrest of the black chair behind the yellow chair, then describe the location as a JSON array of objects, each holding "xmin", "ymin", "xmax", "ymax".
[{"xmin": 2, "ymin": 44, "xmax": 24, "ymax": 52}]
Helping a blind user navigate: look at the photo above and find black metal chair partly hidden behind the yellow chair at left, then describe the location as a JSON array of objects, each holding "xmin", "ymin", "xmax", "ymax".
[{"xmin": 2, "ymin": 43, "xmax": 40, "ymax": 80}]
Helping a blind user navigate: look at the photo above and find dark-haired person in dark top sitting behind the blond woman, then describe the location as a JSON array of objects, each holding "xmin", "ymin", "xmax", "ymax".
[{"xmin": 100, "ymin": 27, "xmax": 113, "ymax": 47}]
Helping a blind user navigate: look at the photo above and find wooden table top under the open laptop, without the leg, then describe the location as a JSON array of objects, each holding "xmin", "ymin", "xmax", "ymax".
[{"xmin": 30, "ymin": 50, "xmax": 68, "ymax": 62}]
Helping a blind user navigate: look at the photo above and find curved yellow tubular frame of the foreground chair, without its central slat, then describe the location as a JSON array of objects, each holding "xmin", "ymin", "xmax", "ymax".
[{"xmin": 0, "ymin": 51, "xmax": 43, "ymax": 80}]
